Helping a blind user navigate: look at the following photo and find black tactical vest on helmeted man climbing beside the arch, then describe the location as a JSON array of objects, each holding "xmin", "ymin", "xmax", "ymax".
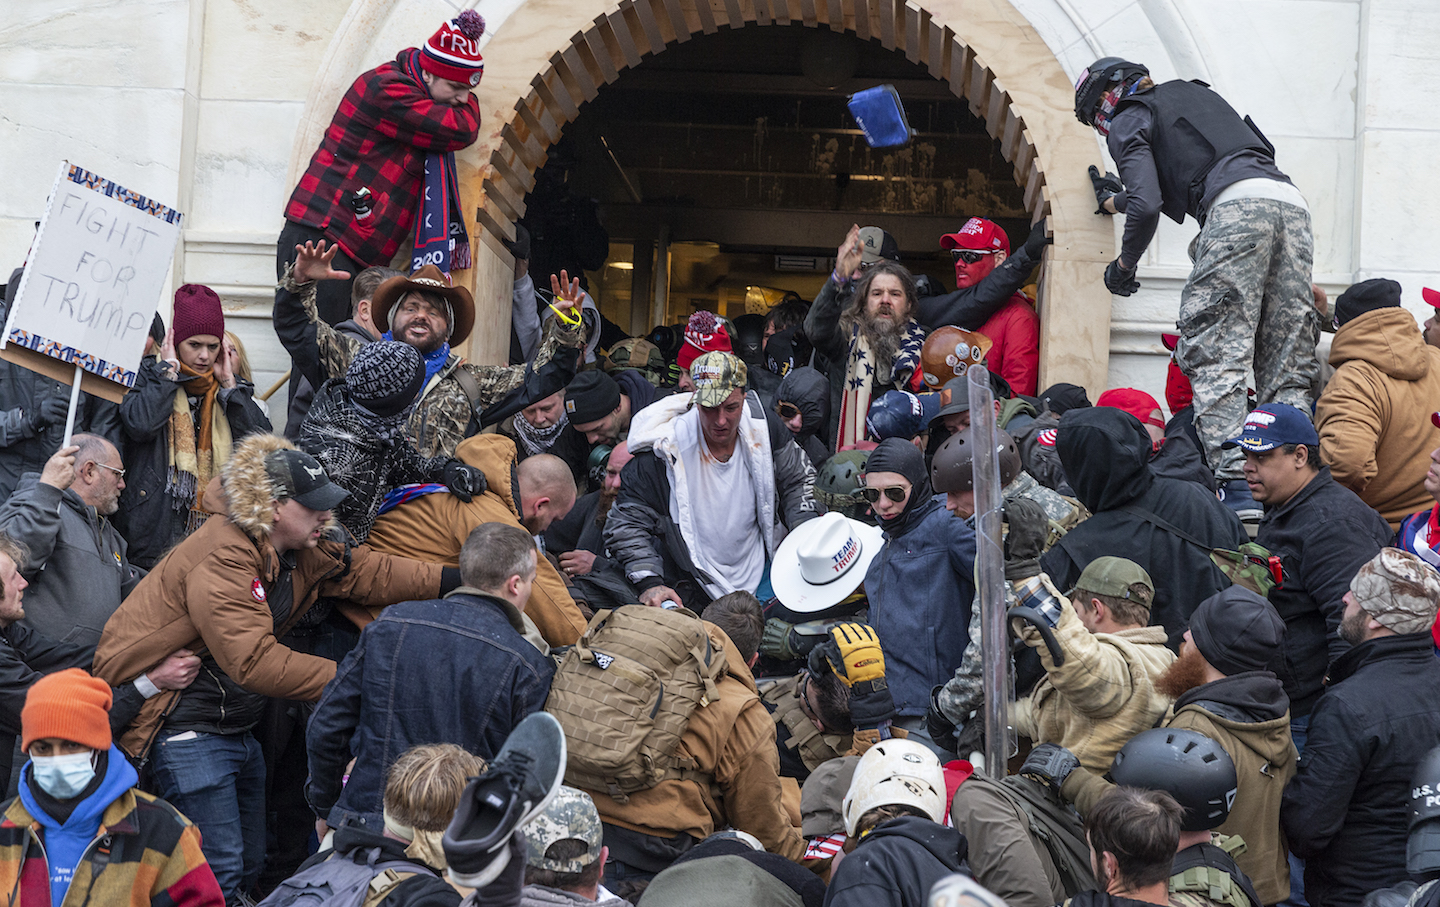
[{"xmin": 1116, "ymin": 81, "xmax": 1274, "ymax": 223}]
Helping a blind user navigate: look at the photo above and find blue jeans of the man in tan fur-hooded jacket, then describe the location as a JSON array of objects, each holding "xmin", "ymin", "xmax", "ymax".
[{"xmin": 151, "ymin": 733, "xmax": 265, "ymax": 904}]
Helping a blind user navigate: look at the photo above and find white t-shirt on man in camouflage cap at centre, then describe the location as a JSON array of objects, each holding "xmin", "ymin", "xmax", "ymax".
[{"xmin": 681, "ymin": 435, "xmax": 765, "ymax": 592}]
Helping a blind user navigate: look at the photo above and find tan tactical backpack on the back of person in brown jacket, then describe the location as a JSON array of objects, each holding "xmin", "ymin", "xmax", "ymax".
[{"xmin": 544, "ymin": 605, "xmax": 726, "ymax": 803}]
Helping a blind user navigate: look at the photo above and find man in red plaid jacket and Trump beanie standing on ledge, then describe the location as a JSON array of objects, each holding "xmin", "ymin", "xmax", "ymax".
[{"xmin": 275, "ymin": 10, "xmax": 485, "ymax": 324}]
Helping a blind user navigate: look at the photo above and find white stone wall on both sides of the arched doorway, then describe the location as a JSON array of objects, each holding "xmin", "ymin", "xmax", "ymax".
[{"xmin": 0, "ymin": 0, "xmax": 1440, "ymax": 423}]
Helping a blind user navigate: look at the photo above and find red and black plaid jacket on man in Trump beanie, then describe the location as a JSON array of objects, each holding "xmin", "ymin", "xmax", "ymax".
[{"xmin": 285, "ymin": 50, "xmax": 480, "ymax": 268}]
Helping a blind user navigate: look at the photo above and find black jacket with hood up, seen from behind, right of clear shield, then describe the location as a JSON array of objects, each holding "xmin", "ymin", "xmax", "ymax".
[{"xmin": 1040, "ymin": 406, "xmax": 1247, "ymax": 648}]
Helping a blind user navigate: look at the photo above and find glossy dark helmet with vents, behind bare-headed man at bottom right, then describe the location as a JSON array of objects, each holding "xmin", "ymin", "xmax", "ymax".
[{"xmin": 1109, "ymin": 727, "xmax": 1238, "ymax": 831}]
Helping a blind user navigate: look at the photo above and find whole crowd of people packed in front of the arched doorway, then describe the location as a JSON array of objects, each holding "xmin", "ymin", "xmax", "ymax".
[{"xmin": 0, "ymin": 17, "xmax": 1440, "ymax": 907}]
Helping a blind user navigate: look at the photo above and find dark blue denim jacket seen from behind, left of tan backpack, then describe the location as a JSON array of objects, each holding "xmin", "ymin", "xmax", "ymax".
[{"xmin": 305, "ymin": 586, "xmax": 554, "ymax": 831}]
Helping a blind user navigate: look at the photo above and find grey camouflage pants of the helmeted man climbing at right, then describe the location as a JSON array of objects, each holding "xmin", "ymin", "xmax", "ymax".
[{"xmin": 1175, "ymin": 199, "xmax": 1320, "ymax": 481}]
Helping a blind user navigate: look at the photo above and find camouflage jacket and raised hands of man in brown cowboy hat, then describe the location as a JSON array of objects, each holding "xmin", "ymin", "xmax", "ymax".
[{"xmin": 278, "ymin": 266, "xmax": 583, "ymax": 456}]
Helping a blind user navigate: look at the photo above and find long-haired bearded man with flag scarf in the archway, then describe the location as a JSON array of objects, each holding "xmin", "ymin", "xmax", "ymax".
[{"xmin": 805, "ymin": 226, "xmax": 924, "ymax": 449}]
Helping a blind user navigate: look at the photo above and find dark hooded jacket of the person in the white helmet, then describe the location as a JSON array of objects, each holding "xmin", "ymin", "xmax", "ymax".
[{"xmin": 825, "ymin": 816, "xmax": 968, "ymax": 907}]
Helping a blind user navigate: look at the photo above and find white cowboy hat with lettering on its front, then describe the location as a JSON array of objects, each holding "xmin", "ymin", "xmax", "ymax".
[{"xmin": 770, "ymin": 513, "xmax": 886, "ymax": 615}]
